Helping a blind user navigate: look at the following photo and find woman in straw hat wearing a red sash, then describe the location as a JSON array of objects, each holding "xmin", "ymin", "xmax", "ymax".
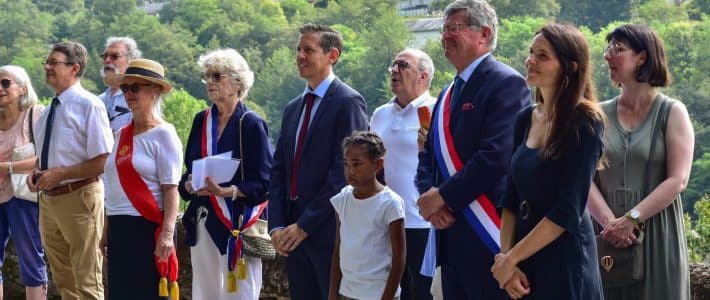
[{"xmin": 101, "ymin": 59, "xmax": 182, "ymax": 299}]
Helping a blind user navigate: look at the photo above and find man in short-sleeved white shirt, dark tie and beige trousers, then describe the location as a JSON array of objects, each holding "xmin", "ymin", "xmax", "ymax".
[{"xmin": 28, "ymin": 42, "xmax": 113, "ymax": 299}]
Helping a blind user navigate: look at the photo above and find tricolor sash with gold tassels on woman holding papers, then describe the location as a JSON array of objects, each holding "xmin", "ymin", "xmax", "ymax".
[{"xmin": 201, "ymin": 105, "xmax": 267, "ymax": 292}]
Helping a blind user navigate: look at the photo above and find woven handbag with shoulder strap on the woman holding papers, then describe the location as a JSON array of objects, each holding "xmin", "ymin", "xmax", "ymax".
[{"xmin": 239, "ymin": 111, "xmax": 276, "ymax": 260}]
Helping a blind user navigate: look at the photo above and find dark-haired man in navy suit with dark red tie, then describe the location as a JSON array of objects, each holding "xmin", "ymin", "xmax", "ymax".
[{"xmin": 269, "ymin": 24, "xmax": 368, "ymax": 300}]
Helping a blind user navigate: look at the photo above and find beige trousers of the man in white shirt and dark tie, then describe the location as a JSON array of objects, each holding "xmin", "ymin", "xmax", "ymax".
[{"xmin": 39, "ymin": 181, "xmax": 104, "ymax": 300}]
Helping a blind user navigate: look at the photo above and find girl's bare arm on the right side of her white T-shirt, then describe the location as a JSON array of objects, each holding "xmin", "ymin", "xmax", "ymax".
[{"xmin": 384, "ymin": 219, "xmax": 407, "ymax": 300}]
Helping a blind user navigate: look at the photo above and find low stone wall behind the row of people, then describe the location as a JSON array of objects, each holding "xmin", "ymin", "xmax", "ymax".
[{"xmin": 2, "ymin": 225, "xmax": 710, "ymax": 300}]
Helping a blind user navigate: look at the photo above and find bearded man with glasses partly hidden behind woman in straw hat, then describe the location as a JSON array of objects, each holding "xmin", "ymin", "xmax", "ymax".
[{"xmin": 99, "ymin": 37, "xmax": 141, "ymax": 132}]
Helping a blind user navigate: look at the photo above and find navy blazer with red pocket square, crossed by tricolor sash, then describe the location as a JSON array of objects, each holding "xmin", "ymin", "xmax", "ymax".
[{"xmin": 415, "ymin": 55, "xmax": 531, "ymax": 270}]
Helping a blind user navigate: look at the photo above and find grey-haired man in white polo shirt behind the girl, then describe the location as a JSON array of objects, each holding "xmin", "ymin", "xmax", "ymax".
[{"xmin": 370, "ymin": 49, "xmax": 436, "ymax": 300}]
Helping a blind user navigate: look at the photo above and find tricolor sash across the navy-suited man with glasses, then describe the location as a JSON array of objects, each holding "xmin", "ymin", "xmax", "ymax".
[{"xmin": 432, "ymin": 83, "xmax": 500, "ymax": 254}]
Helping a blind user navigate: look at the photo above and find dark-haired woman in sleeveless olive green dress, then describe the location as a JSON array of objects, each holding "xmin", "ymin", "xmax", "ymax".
[{"xmin": 588, "ymin": 25, "xmax": 694, "ymax": 300}]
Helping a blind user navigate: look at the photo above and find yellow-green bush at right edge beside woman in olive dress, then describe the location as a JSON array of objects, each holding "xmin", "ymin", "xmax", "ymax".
[{"xmin": 684, "ymin": 195, "xmax": 710, "ymax": 263}]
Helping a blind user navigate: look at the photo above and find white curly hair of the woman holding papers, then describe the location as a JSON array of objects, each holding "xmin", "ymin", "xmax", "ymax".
[{"xmin": 197, "ymin": 48, "xmax": 254, "ymax": 100}]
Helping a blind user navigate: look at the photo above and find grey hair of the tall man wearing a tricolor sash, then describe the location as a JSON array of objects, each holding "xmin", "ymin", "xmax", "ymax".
[{"xmin": 444, "ymin": 0, "xmax": 498, "ymax": 52}]
